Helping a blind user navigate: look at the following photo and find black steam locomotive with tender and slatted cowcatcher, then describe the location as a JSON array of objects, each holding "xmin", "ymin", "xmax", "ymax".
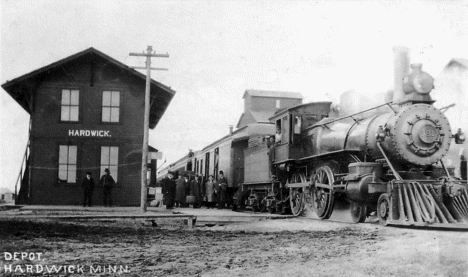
[{"xmin": 159, "ymin": 48, "xmax": 468, "ymax": 229}]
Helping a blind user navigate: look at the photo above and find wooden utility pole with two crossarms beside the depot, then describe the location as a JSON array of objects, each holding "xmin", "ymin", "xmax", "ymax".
[{"xmin": 130, "ymin": 46, "xmax": 169, "ymax": 212}]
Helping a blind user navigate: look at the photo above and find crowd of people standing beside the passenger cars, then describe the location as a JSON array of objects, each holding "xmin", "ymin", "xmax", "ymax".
[{"xmin": 161, "ymin": 170, "xmax": 236, "ymax": 209}]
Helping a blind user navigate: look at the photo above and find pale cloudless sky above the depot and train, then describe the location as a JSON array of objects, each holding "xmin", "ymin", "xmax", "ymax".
[{"xmin": 0, "ymin": 0, "xmax": 468, "ymax": 191}]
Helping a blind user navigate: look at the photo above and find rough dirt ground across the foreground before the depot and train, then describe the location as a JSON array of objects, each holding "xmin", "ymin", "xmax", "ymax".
[{"xmin": 0, "ymin": 218, "xmax": 468, "ymax": 276}]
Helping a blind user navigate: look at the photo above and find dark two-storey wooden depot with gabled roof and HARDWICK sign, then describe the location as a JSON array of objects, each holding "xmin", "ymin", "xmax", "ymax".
[{"xmin": 2, "ymin": 48, "xmax": 175, "ymax": 206}]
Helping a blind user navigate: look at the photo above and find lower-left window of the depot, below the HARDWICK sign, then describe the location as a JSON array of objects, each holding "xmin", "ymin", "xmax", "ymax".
[{"xmin": 58, "ymin": 145, "xmax": 78, "ymax": 183}]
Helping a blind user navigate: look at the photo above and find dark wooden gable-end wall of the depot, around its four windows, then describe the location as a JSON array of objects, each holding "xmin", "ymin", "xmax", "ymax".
[{"xmin": 29, "ymin": 56, "xmax": 155, "ymax": 206}]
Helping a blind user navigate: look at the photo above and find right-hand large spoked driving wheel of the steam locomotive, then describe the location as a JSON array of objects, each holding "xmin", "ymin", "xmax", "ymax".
[{"xmin": 312, "ymin": 165, "xmax": 335, "ymax": 219}]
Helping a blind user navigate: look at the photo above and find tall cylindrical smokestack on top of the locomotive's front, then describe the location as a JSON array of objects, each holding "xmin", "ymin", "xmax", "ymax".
[{"xmin": 393, "ymin": 46, "xmax": 410, "ymax": 103}]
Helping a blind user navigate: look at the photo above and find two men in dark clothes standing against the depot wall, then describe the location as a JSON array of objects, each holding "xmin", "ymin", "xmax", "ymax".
[{"xmin": 81, "ymin": 168, "xmax": 115, "ymax": 207}]
